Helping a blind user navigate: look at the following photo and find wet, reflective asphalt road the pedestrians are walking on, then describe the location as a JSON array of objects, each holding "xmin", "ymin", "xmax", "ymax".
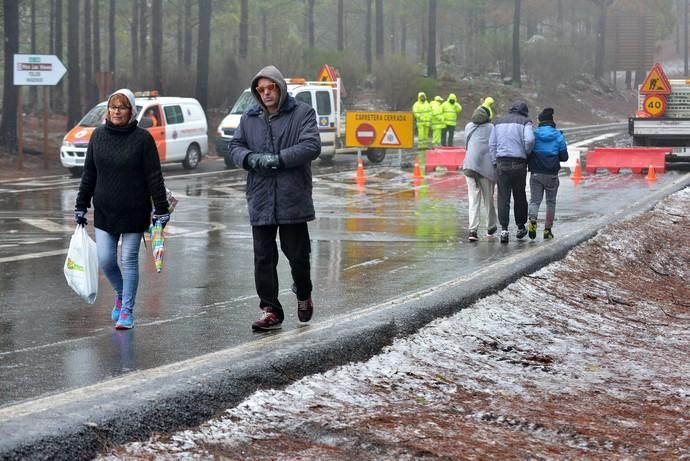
[{"xmin": 0, "ymin": 126, "xmax": 685, "ymax": 456}]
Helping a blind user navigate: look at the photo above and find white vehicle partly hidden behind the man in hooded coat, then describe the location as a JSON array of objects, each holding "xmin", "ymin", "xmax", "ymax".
[{"xmin": 216, "ymin": 78, "xmax": 386, "ymax": 168}]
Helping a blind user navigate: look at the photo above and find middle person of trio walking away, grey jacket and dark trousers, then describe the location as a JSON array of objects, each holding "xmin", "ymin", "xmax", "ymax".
[{"xmin": 489, "ymin": 101, "xmax": 534, "ymax": 243}]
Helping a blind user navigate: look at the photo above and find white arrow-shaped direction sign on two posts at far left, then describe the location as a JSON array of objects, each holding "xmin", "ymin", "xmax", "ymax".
[{"xmin": 13, "ymin": 54, "xmax": 67, "ymax": 170}]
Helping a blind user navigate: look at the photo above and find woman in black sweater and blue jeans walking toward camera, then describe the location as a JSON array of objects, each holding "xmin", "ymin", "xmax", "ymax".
[{"xmin": 74, "ymin": 89, "xmax": 170, "ymax": 329}]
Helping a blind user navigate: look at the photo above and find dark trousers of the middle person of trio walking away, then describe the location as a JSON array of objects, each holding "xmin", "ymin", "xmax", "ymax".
[{"xmin": 496, "ymin": 157, "xmax": 527, "ymax": 230}]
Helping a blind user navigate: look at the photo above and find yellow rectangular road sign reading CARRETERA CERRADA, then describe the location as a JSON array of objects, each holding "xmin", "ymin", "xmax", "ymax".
[{"xmin": 345, "ymin": 112, "xmax": 414, "ymax": 149}]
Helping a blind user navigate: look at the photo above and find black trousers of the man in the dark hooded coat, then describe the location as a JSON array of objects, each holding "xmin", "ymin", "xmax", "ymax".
[{"xmin": 252, "ymin": 222, "xmax": 312, "ymax": 320}]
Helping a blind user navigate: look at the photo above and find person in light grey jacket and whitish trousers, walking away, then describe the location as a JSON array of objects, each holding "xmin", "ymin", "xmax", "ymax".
[{"xmin": 462, "ymin": 106, "xmax": 497, "ymax": 242}]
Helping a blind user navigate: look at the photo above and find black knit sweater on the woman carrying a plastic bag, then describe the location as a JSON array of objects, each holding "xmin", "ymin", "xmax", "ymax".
[{"xmin": 75, "ymin": 121, "xmax": 168, "ymax": 234}]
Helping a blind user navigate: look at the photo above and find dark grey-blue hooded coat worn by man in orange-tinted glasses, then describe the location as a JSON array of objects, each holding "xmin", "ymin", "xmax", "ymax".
[{"xmin": 230, "ymin": 66, "xmax": 321, "ymax": 226}]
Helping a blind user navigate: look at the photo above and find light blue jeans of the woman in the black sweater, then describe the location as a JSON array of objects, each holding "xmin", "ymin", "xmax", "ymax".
[{"xmin": 96, "ymin": 228, "xmax": 143, "ymax": 310}]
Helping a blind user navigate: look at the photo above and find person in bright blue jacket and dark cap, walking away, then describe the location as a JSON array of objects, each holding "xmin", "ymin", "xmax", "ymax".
[{"xmin": 527, "ymin": 107, "xmax": 568, "ymax": 240}]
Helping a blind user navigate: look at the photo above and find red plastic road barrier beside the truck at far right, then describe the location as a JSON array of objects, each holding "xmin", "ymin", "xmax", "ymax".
[{"xmin": 586, "ymin": 147, "xmax": 671, "ymax": 174}]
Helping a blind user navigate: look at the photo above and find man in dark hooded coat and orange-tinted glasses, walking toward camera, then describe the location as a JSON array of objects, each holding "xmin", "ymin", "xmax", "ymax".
[{"xmin": 230, "ymin": 66, "xmax": 321, "ymax": 331}]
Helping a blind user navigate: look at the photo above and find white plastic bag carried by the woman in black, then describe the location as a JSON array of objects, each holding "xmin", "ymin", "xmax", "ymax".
[{"xmin": 65, "ymin": 225, "xmax": 98, "ymax": 304}]
